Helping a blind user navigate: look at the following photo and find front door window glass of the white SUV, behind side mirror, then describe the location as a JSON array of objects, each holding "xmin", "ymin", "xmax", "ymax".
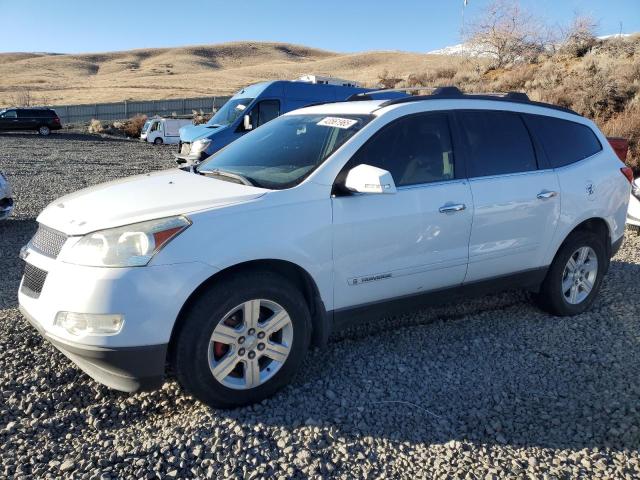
[{"xmin": 347, "ymin": 113, "xmax": 454, "ymax": 186}]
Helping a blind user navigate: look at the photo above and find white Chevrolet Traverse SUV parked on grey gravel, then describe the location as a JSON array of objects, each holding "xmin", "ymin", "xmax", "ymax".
[{"xmin": 19, "ymin": 87, "xmax": 630, "ymax": 407}]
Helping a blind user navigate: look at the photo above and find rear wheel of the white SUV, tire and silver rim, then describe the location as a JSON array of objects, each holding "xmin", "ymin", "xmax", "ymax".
[{"xmin": 536, "ymin": 231, "xmax": 609, "ymax": 316}]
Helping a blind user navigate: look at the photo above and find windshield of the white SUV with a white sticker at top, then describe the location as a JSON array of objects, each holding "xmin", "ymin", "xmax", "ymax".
[{"xmin": 198, "ymin": 115, "xmax": 373, "ymax": 190}]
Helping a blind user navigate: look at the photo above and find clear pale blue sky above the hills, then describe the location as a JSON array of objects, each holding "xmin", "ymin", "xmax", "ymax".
[{"xmin": 0, "ymin": 0, "xmax": 640, "ymax": 53}]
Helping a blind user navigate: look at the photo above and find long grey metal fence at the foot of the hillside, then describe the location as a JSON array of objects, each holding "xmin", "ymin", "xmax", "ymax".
[{"xmin": 51, "ymin": 97, "xmax": 230, "ymax": 123}]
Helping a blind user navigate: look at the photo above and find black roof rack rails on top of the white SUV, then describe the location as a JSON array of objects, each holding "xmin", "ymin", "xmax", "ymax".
[{"xmin": 347, "ymin": 86, "xmax": 580, "ymax": 116}]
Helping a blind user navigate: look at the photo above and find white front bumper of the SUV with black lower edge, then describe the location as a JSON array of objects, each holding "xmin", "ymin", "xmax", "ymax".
[{"xmin": 18, "ymin": 247, "xmax": 216, "ymax": 392}]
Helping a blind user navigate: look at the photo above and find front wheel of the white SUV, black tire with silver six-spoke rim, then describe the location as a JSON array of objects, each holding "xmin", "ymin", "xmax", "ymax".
[{"xmin": 173, "ymin": 272, "xmax": 311, "ymax": 408}]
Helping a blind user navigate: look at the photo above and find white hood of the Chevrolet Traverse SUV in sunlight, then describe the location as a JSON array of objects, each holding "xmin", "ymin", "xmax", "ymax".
[{"xmin": 38, "ymin": 169, "xmax": 268, "ymax": 235}]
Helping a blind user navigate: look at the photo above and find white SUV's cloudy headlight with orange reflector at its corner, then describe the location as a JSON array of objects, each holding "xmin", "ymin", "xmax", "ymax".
[{"xmin": 61, "ymin": 217, "xmax": 191, "ymax": 267}]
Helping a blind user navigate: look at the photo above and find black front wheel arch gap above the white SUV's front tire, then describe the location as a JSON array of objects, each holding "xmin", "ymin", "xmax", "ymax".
[{"xmin": 168, "ymin": 259, "xmax": 330, "ymax": 366}]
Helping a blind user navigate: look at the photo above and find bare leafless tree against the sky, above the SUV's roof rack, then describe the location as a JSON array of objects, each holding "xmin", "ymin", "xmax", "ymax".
[{"xmin": 466, "ymin": 0, "xmax": 547, "ymax": 68}]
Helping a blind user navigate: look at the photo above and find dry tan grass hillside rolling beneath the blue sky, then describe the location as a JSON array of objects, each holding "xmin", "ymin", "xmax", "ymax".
[{"xmin": 0, "ymin": 42, "xmax": 461, "ymax": 105}]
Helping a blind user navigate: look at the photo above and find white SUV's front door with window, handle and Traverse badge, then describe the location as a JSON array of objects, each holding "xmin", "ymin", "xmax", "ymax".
[{"xmin": 332, "ymin": 113, "xmax": 473, "ymax": 310}]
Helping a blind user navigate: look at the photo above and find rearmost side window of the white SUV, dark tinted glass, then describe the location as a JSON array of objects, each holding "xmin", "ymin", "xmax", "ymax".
[{"xmin": 525, "ymin": 115, "xmax": 602, "ymax": 168}]
